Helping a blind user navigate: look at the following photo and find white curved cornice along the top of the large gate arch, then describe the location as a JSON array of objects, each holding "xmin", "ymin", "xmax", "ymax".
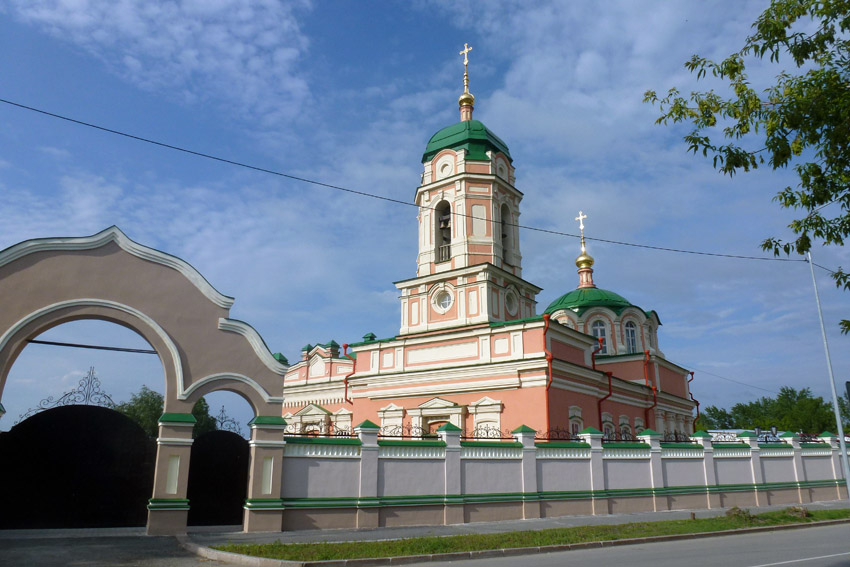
[{"xmin": 0, "ymin": 226, "xmax": 234, "ymax": 309}]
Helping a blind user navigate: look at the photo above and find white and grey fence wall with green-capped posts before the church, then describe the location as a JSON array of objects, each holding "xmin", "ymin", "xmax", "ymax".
[{"xmin": 281, "ymin": 422, "xmax": 847, "ymax": 530}]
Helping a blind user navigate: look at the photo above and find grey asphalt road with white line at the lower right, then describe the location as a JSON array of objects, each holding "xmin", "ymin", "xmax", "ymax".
[{"xmin": 428, "ymin": 524, "xmax": 850, "ymax": 567}]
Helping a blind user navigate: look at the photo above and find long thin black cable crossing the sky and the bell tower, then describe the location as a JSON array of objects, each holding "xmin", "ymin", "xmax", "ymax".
[{"xmin": 0, "ymin": 99, "xmax": 805, "ymax": 262}]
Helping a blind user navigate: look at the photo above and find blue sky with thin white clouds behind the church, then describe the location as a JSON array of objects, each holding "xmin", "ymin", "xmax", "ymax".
[{"xmin": 0, "ymin": 0, "xmax": 850, "ymax": 430}]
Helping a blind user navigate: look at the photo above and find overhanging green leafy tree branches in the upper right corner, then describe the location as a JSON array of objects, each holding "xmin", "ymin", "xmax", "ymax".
[{"xmin": 644, "ymin": 0, "xmax": 850, "ymax": 333}]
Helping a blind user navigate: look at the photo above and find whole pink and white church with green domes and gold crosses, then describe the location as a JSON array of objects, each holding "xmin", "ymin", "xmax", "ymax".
[{"xmin": 280, "ymin": 47, "xmax": 696, "ymax": 439}]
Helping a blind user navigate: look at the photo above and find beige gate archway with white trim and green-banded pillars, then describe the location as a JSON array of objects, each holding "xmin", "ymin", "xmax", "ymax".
[{"xmin": 0, "ymin": 227, "xmax": 286, "ymax": 534}]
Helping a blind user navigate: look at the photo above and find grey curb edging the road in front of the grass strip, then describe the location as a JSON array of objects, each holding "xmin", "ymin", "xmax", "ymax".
[{"xmin": 176, "ymin": 518, "xmax": 850, "ymax": 567}]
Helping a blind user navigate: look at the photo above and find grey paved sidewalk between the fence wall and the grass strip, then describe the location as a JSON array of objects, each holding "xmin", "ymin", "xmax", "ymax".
[{"xmin": 188, "ymin": 500, "xmax": 850, "ymax": 547}]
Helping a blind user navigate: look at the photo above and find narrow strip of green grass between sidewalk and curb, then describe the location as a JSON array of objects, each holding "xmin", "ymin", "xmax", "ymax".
[{"xmin": 214, "ymin": 507, "xmax": 850, "ymax": 561}]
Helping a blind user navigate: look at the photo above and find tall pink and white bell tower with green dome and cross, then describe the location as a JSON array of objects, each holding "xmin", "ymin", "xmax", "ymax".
[{"xmin": 396, "ymin": 44, "xmax": 540, "ymax": 334}]
